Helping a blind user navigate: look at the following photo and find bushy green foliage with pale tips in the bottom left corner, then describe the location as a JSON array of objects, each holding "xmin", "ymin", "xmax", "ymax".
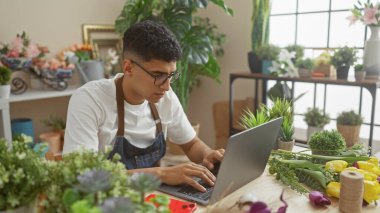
[{"xmin": 0, "ymin": 137, "xmax": 49, "ymax": 211}]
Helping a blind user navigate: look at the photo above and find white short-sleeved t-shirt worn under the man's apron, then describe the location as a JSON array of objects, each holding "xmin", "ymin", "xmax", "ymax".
[{"xmin": 63, "ymin": 75, "xmax": 196, "ymax": 154}]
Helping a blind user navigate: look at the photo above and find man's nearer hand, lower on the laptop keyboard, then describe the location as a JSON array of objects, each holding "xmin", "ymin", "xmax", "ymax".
[{"xmin": 159, "ymin": 163, "xmax": 216, "ymax": 192}]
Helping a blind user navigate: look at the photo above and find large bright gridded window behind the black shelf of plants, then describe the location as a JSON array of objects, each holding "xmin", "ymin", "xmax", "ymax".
[{"xmin": 268, "ymin": 0, "xmax": 380, "ymax": 143}]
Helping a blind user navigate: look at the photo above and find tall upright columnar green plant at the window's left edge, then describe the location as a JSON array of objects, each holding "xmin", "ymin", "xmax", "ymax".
[{"xmin": 251, "ymin": 0, "xmax": 271, "ymax": 53}]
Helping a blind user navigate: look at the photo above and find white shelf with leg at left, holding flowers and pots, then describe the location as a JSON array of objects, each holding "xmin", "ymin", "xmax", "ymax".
[{"xmin": 0, "ymin": 86, "xmax": 78, "ymax": 146}]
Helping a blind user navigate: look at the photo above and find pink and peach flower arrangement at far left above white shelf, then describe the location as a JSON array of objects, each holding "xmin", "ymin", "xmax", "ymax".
[{"xmin": 0, "ymin": 32, "xmax": 49, "ymax": 70}]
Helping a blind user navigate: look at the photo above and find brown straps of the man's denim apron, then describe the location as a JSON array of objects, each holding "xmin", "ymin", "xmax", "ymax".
[{"xmin": 115, "ymin": 77, "xmax": 162, "ymax": 137}]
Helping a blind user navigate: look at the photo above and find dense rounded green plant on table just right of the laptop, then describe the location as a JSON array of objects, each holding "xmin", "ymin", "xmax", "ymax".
[{"xmin": 309, "ymin": 130, "xmax": 346, "ymax": 156}]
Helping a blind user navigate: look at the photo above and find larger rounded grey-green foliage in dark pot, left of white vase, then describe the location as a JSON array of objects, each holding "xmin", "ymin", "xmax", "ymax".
[{"xmin": 331, "ymin": 46, "xmax": 357, "ymax": 69}]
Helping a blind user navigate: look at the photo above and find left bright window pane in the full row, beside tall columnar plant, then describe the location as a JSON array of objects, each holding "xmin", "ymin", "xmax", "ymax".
[{"xmin": 269, "ymin": 15, "xmax": 296, "ymax": 47}]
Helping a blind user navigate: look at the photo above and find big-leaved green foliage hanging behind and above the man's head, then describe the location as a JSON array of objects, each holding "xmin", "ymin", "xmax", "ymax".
[{"xmin": 115, "ymin": 0, "xmax": 233, "ymax": 111}]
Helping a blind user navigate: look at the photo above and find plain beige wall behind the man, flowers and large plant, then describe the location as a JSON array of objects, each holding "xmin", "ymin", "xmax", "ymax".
[{"xmin": 0, "ymin": 0, "xmax": 253, "ymax": 146}]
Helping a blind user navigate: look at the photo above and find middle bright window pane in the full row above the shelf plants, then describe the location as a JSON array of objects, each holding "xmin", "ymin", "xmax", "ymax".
[{"xmin": 297, "ymin": 13, "xmax": 328, "ymax": 47}]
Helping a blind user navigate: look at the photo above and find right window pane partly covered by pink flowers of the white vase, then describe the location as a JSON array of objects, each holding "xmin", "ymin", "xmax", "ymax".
[{"xmin": 329, "ymin": 11, "xmax": 364, "ymax": 47}]
